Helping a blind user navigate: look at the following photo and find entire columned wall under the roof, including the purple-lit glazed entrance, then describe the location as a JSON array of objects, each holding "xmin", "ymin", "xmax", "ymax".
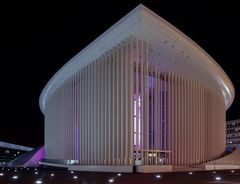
[{"xmin": 45, "ymin": 36, "xmax": 225, "ymax": 165}]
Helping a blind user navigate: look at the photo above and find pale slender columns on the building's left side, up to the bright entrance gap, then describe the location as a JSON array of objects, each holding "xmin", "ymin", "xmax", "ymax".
[{"xmin": 45, "ymin": 37, "xmax": 139, "ymax": 165}]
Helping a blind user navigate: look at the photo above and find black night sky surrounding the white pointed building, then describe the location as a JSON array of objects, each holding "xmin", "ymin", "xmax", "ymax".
[{"xmin": 0, "ymin": 0, "xmax": 240, "ymax": 147}]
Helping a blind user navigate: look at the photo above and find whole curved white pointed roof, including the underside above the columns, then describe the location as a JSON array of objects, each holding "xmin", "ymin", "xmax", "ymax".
[{"xmin": 39, "ymin": 5, "xmax": 235, "ymax": 113}]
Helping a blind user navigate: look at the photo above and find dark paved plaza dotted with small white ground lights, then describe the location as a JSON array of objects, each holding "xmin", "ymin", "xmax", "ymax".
[{"xmin": 0, "ymin": 168, "xmax": 240, "ymax": 184}]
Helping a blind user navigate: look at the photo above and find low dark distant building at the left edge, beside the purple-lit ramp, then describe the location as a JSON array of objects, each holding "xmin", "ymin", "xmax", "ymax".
[{"xmin": 0, "ymin": 141, "xmax": 33, "ymax": 166}]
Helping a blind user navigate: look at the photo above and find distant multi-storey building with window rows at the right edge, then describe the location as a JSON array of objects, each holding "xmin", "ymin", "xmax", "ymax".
[{"xmin": 226, "ymin": 119, "xmax": 240, "ymax": 146}]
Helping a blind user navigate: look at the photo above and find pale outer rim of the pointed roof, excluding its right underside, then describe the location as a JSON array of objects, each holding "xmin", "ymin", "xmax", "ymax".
[{"xmin": 39, "ymin": 4, "xmax": 235, "ymax": 113}]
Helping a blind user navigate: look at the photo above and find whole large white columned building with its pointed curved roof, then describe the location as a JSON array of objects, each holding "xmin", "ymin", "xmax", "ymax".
[{"xmin": 40, "ymin": 5, "xmax": 234, "ymax": 170}]
